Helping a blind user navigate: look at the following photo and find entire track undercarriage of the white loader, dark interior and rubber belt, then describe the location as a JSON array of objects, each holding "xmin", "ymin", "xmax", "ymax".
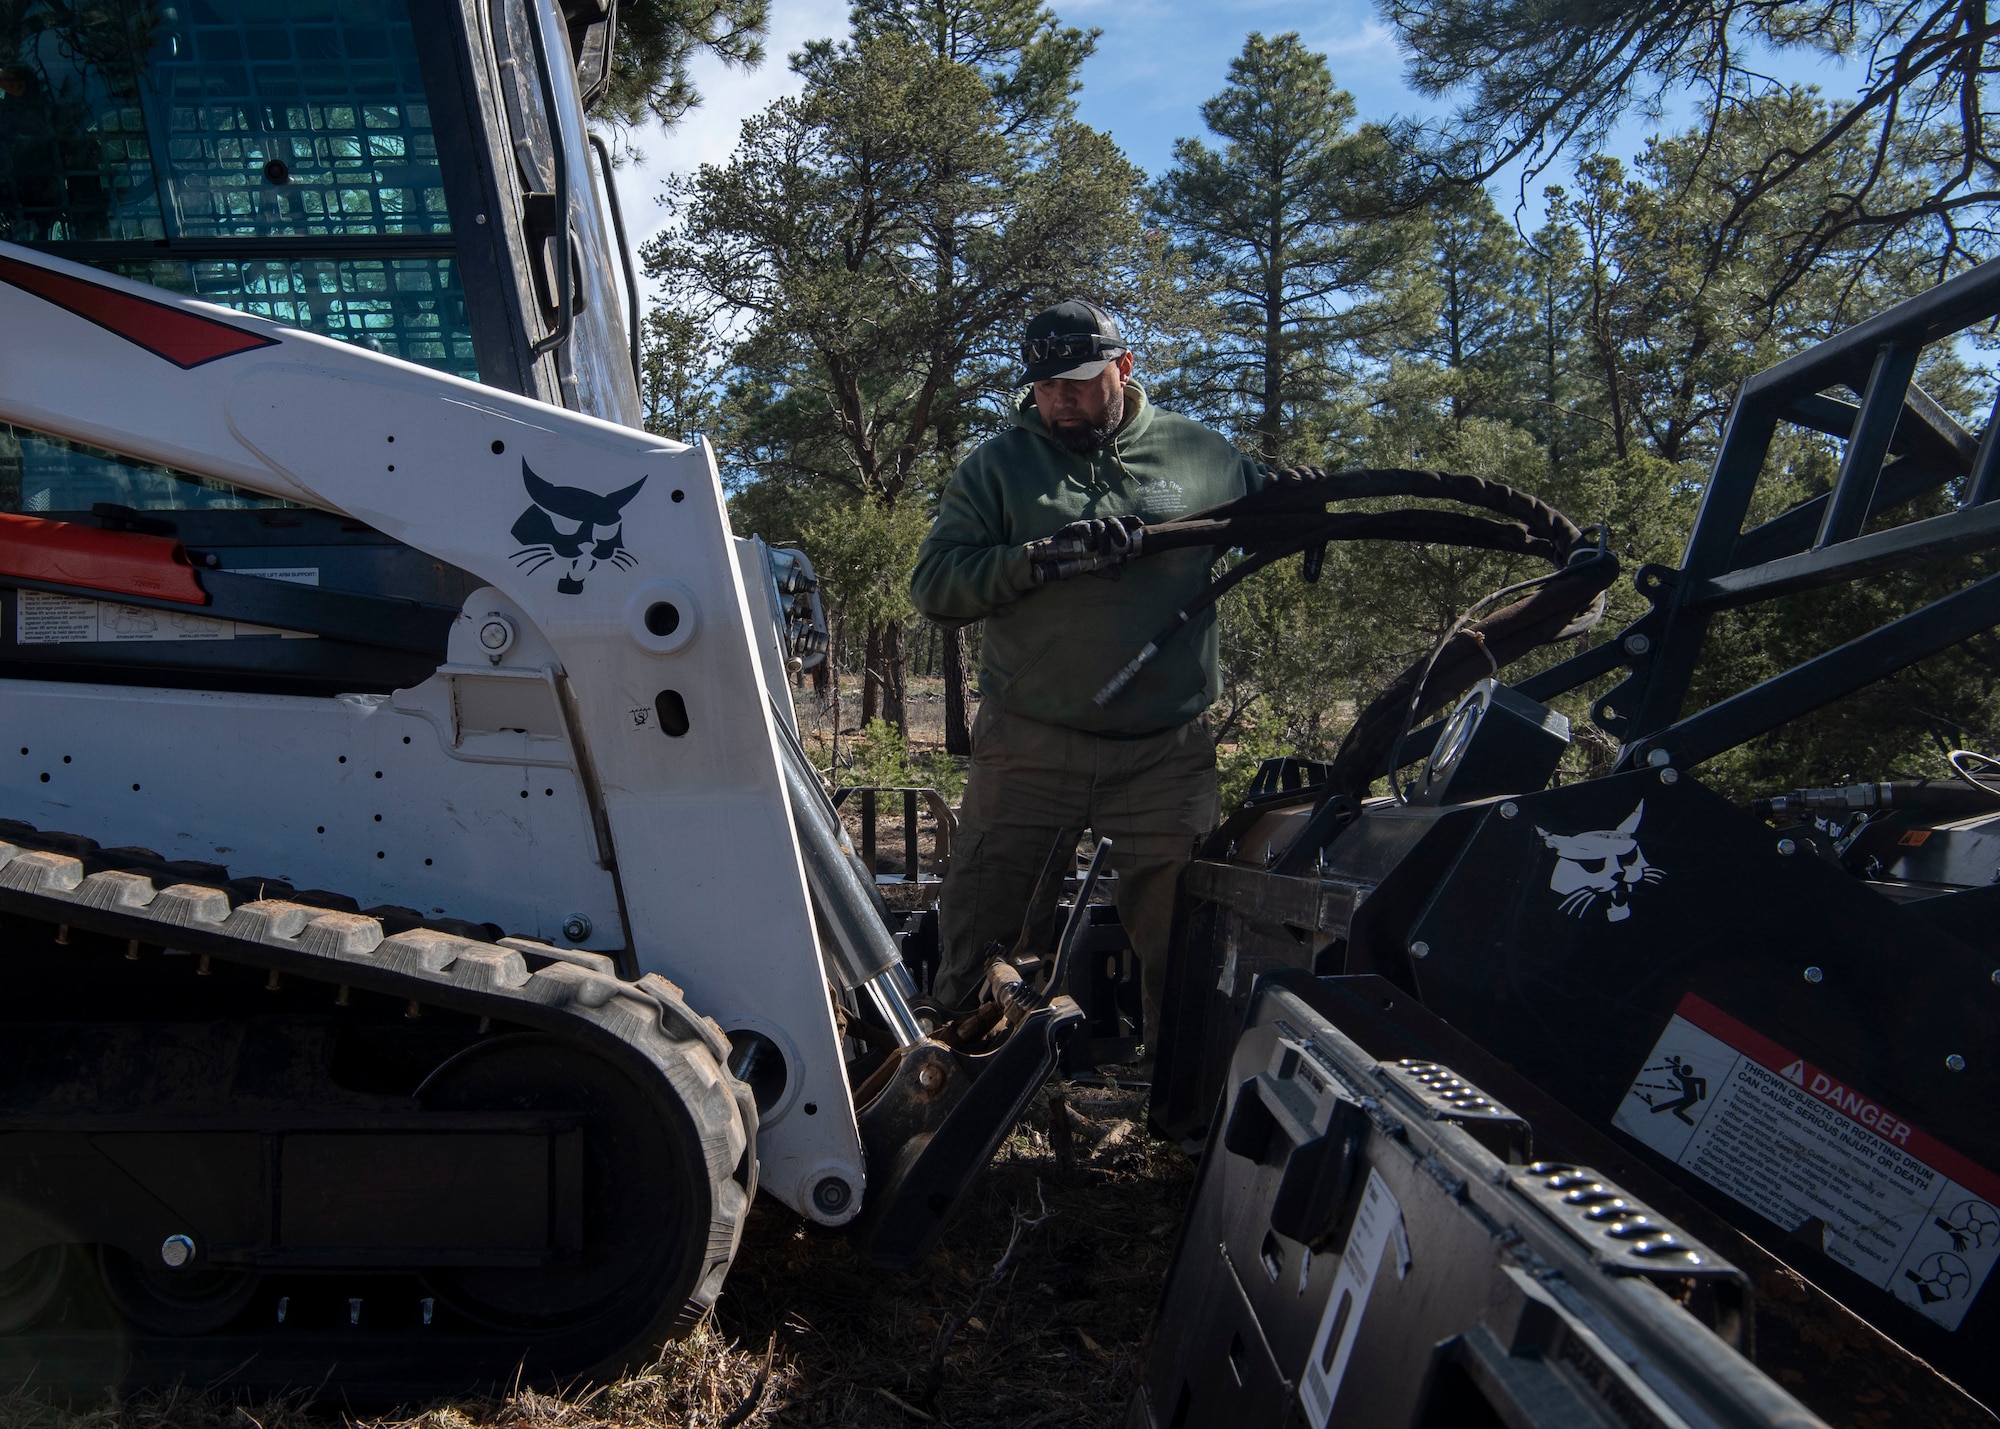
[{"xmin": 0, "ymin": 812, "xmax": 756, "ymax": 1395}]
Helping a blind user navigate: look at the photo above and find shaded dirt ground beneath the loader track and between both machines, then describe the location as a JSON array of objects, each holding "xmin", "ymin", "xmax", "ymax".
[{"xmin": 0, "ymin": 1087, "xmax": 1194, "ymax": 1429}]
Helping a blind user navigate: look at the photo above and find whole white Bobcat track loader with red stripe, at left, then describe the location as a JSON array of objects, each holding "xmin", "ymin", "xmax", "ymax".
[{"xmin": 0, "ymin": 0, "xmax": 1082, "ymax": 1395}]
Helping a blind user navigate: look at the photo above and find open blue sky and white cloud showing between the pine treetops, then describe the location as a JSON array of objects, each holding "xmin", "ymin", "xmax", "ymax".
[{"xmin": 618, "ymin": 0, "xmax": 1854, "ymax": 253}]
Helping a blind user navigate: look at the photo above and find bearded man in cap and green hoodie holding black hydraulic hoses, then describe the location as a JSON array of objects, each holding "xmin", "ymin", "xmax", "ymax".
[{"xmin": 910, "ymin": 298, "xmax": 1262, "ymax": 1041}]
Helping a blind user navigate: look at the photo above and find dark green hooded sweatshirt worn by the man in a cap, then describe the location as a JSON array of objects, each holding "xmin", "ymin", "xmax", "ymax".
[{"xmin": 910, "ymin": 384, "xmax": 1262, "ymax": 735}]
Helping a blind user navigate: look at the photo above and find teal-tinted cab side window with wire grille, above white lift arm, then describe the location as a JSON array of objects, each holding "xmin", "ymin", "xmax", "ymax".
[{"xmin": 0, "ymin": 0, "xmax": 478, "ymax": 378}]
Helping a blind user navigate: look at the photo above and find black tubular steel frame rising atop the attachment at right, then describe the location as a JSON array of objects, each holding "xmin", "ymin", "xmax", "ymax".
[{"xmin": 1504, "ymin": 260, "xmax": 2000, "ymax": 769}]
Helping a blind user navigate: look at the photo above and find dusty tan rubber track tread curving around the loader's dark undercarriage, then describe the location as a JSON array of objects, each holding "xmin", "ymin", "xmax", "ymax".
[{"xmin": 0, "ymin": 831, "xmax": 756, "ymax": 1355}]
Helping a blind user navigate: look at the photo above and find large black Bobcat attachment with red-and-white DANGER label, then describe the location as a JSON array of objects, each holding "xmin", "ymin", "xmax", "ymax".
[{"xmin": 1134, "ymin": 262, "xmax": 2000, "ymax": 1429}]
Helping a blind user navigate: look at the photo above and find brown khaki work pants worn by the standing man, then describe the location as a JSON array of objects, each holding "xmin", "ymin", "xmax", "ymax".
[{"xmin": 932, "ymin": 702, "xmax": 1216, "ymax": 1043}]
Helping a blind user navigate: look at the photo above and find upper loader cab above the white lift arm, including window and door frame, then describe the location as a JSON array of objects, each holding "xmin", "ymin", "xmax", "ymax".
[{"xmin": 0, "ymin": 0, "xmax": 640, "ymax": 426}]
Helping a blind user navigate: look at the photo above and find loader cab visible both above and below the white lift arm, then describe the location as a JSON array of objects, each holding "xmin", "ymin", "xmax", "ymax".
[{"xmin": 0, "ymin": 0, "xmax": 640, "ymax": 694}]
